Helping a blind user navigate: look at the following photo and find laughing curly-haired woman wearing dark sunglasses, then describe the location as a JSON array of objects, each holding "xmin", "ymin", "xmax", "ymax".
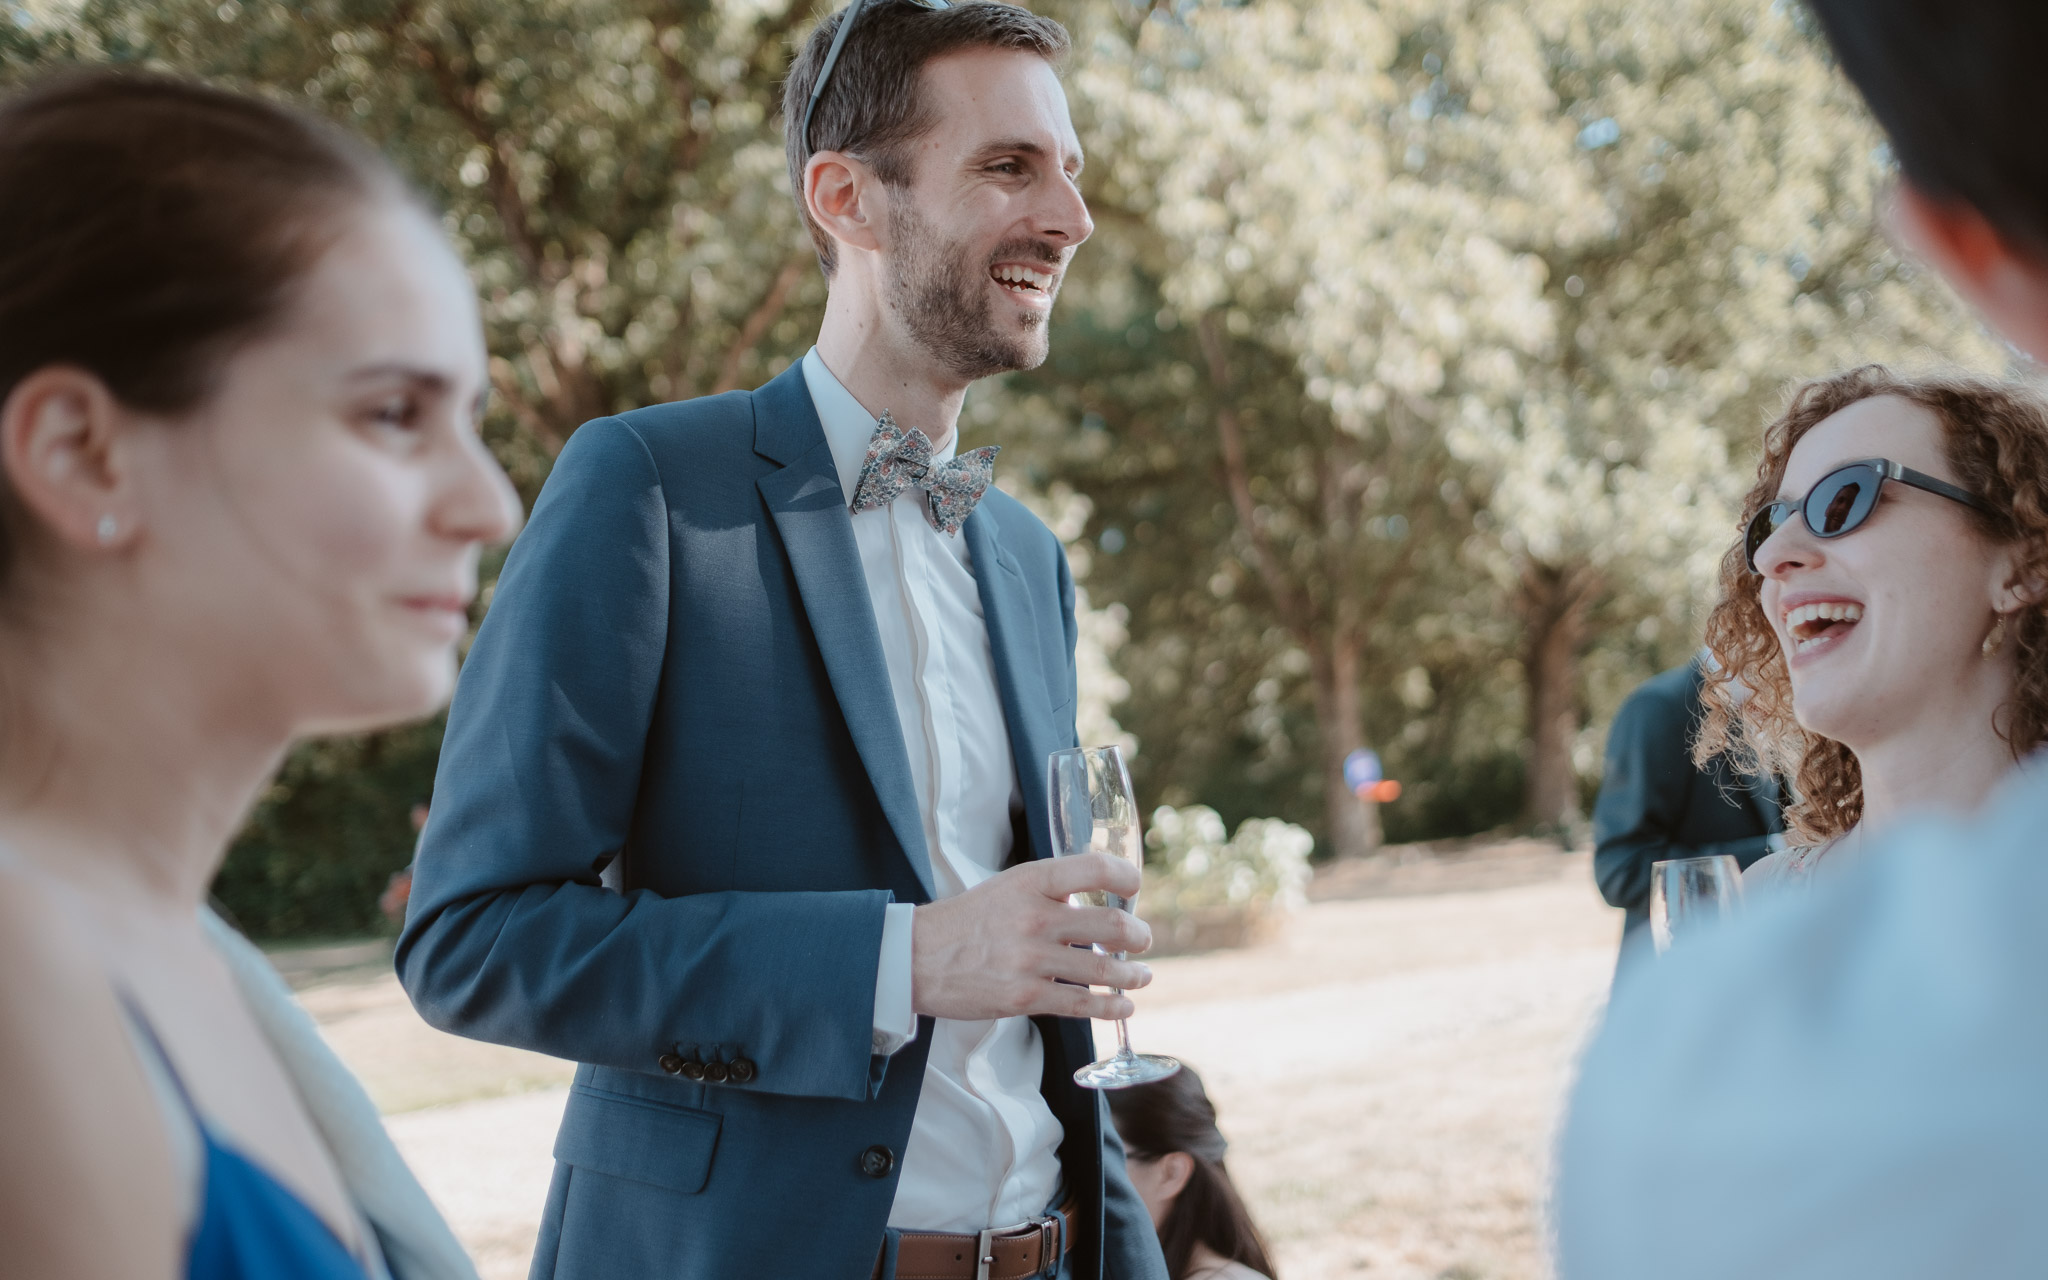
[{"xmin": 1696, "ymin": 365, "xmax": 2048, "ymax": 883}]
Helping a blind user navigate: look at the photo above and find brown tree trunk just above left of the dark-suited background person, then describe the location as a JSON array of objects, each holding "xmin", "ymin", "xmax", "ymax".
[{"xmin": 1520, "ymin": 563, "xmax": 1595, "ymax": 831}]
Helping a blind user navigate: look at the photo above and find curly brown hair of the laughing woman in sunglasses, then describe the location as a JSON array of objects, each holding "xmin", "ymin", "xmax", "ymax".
[{"xmin": 1694, "ymin": 365, "xmax": 2048, "ymax": 844}]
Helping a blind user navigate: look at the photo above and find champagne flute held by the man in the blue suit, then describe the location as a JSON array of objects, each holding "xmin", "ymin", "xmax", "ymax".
[{"xmin": 1047, "ymin": 748, "xmax": 1180, "ymax": 1090}]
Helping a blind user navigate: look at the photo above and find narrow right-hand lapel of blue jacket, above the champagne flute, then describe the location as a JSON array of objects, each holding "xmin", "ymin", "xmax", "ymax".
[{"xmin": 961, "ymin": 506, "xmax": 1067, "ymax": 858}]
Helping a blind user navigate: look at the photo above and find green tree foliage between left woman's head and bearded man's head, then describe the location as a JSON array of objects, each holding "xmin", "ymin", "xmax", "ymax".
[{"xmin": 0, "ymin": 0, "xmax": 823, "ymax": 458}]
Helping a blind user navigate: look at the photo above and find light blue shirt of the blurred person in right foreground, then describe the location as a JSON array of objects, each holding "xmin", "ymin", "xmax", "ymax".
[{"xmin": 1554, "ymin": 756, "xmax": 2048, "ymax": 1280}]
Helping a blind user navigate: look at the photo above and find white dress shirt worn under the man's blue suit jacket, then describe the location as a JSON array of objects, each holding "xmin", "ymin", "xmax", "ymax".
[{"xmin": 803, "ymin": 348, "xmax": 1065, "ymax": 1231}]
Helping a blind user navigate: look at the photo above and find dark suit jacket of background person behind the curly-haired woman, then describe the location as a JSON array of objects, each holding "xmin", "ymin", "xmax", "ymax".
[{"xmin": 1593, "ymin": 653, "xmax": 1786, "ymax": 965}]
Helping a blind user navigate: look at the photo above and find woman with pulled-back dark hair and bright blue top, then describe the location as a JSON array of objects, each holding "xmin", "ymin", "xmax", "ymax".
[{"xmin": 0, "ymin": 72, "xmax": 518, "ymax": 1280}]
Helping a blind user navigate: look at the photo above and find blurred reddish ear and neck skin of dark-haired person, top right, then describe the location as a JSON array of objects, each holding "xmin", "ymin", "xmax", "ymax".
[{"xmin": 1884, "ymin": 182, "xmax": 2048, "ymax": 362}]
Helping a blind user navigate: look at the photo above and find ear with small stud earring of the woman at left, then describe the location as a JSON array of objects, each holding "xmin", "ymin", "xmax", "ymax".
[{"xmin": 0, "ymin": 365, "xmax": 137, "ymax": 547}]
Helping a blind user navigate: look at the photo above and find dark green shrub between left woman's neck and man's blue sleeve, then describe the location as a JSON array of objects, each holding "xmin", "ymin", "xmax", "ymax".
[{"xmin": 213, "ymin": 719, "xmax": 442, "ymax": 940}]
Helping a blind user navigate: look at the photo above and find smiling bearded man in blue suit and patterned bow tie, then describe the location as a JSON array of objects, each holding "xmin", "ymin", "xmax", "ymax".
[{"xmin": 397, "ymin": 0, "xmax": 1165, "ymax": 1280}]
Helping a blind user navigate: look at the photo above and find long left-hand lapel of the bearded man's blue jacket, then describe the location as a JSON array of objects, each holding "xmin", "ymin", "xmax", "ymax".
[{"xmin": 754, "ymin": 365, "xmax": 938, "ymax": 899}]
